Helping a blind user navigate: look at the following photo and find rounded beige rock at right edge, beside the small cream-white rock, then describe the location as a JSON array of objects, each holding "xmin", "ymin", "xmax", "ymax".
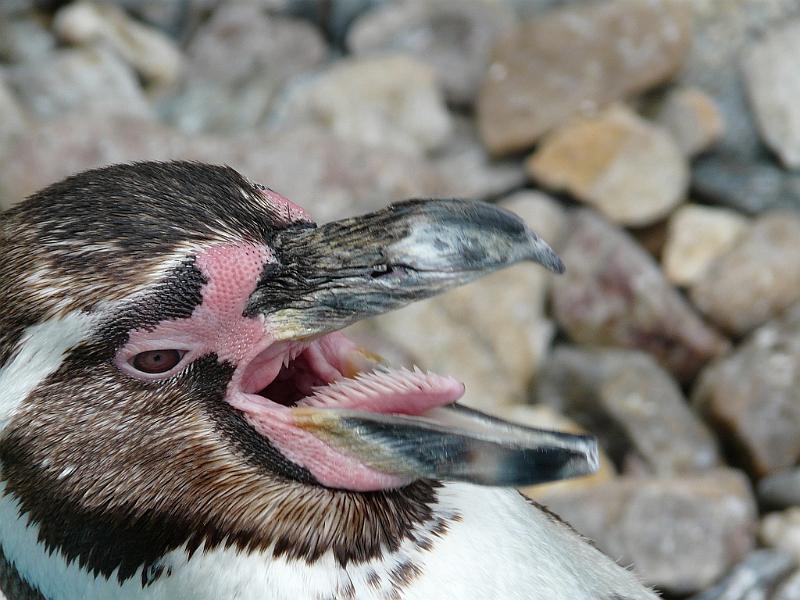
[{"xmin": 690, "ymin": 212, "xmax": 800, "ymax": 335}]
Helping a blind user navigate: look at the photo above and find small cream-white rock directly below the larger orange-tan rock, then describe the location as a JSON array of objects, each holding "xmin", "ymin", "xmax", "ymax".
[{"xmin": 662, "ymin": 204, "xmax": 748, "ymax": 286}]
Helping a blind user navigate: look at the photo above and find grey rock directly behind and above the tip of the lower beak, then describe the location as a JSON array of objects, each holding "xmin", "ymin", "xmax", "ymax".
[{"xmin": 534, "ymin": 346, "xmax": 720, "ymax": 475}]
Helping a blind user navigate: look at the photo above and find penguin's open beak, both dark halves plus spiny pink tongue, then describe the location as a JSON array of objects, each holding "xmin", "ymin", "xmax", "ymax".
[{"xmin": 248, "ymin": 200, "xmax": 598, "ymax": 489}]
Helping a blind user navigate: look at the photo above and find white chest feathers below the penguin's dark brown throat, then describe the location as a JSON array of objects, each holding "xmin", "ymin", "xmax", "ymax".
[{"xmin": 0, "ymin": 484, "xmax": 655, "ymax": 600}]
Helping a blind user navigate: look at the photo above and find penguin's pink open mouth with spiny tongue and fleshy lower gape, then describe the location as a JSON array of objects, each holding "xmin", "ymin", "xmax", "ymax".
[{"xmin": 228, "ymin": 333, "xmax": 464, "ymax": 491}]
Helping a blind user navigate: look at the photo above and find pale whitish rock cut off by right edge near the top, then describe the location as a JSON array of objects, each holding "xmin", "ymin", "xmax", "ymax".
[{"xmin": 742, "ymin": 19, "xmax": 800, "ymax": 169}]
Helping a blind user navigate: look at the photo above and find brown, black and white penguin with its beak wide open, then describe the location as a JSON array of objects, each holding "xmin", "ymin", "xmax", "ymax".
[{"xmin": 0, "ymin": 162, "xmax": 656, "ymax": 600}]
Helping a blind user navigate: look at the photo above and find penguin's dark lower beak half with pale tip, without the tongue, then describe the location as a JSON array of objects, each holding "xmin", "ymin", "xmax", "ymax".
[{"xmin": 294, "ymin": 404, "xmax": 599, "ymax": 486}]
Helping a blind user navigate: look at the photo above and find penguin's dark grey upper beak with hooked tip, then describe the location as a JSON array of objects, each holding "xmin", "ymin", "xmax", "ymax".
[{"xmin": 247, "ymin": 200, "xmax": 564, "ymax": 340}]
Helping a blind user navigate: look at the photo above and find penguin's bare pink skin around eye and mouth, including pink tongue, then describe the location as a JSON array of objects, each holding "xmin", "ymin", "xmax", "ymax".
[{"xmin": 116, "ymin": 239, "xmax": 463, "ymax": 491}]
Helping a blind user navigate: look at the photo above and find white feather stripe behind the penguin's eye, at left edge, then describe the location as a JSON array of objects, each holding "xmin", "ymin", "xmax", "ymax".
[{"xmin": 0, "ymin": 311, "xmax": 94, "ymax": 430}]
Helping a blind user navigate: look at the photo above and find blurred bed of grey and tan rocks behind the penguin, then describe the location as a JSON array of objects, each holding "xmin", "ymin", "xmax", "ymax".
[{"xmin": 0, "ymin": 0, "xmax": 800, "ymax": 600}]
